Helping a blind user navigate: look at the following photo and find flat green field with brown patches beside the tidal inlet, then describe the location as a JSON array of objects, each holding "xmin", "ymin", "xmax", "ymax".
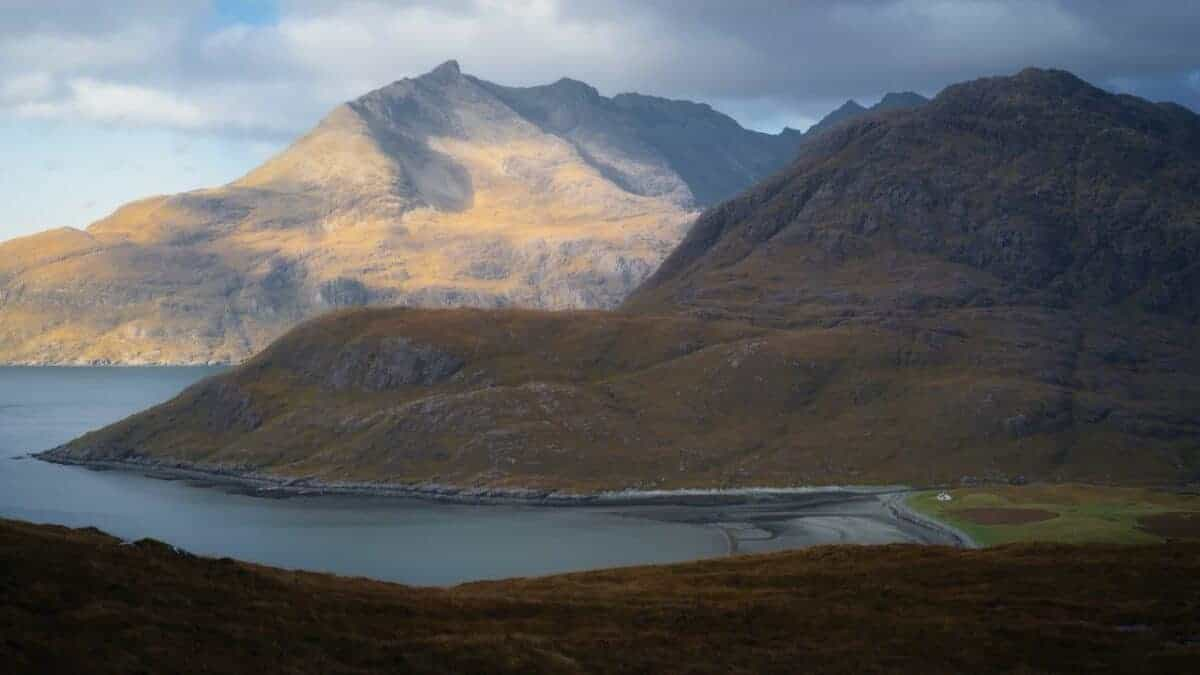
[{"xmin": 907, "ymin": 485, "xmax": 1200, "ymax": 545}]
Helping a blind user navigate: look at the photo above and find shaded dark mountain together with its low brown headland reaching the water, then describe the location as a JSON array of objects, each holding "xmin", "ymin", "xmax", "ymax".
[{"xmin": 44, "ymin": 70, "xmax": 1200, "ymax": 489}]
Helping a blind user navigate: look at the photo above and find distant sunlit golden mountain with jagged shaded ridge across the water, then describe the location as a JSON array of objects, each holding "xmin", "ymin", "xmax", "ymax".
[{"xmin": 0, "ymin": 61, "xmax": 798, "ymax": 363}]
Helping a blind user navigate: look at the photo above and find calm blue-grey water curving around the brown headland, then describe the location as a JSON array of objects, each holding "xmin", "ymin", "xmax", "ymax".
[{"xmin": 0, "ymin": 368, "xmax": 726, "ymax": 584}]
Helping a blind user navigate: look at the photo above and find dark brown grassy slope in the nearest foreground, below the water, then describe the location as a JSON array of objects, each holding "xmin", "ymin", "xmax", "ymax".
[{"xmin": 0, "ymin": 521, "xmax": 1200, "ymax": 673}]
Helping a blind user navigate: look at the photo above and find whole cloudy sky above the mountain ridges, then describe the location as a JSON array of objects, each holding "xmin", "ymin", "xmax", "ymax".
[{"xmin": 0, "ymin": 0, "xmax": 1200, "ymax": 240}]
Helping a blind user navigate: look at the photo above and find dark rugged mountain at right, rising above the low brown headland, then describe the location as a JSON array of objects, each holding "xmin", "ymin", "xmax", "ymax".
[{"xmin": 629, "ymin": 70, "xmax": 1200, "ymax": 324}]
